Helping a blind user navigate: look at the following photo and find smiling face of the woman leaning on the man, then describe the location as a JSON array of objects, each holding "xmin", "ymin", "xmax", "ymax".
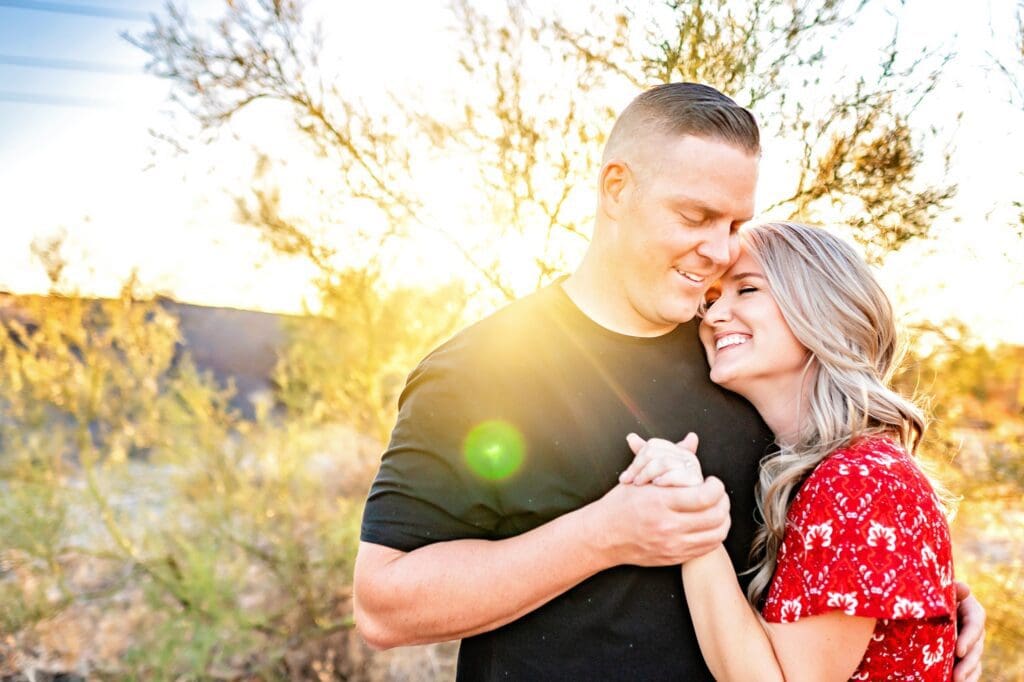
[{"xmin": 700, "ymin": 250, "xmax": 809, "ymax": 398}]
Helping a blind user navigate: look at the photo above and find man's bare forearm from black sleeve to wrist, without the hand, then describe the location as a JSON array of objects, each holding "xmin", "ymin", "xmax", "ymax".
[{"xmin": 355, "ymin": 507, "xmax": 611, "ymax": 648}]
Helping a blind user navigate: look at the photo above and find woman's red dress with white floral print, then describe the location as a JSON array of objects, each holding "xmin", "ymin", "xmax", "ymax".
[{"xmin": 762, "ymin": 437, "xmax": 956, "ymax": 681}]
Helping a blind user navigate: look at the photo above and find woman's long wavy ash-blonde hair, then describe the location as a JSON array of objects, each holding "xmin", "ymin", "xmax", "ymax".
[{"xmin": 740, "ymin": 222, "xmax": 926, "ymax": 605}]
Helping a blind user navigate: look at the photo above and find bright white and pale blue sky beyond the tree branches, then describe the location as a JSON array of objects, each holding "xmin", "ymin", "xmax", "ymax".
[{"xmin": 0, "ymin": 0, "xmax": 1024, "ymax": 343}]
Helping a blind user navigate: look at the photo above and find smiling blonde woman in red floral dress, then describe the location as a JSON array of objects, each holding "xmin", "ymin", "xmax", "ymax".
[{"xmin": 622, "ymin": 223, "xmax": 955, "ymax": 680}]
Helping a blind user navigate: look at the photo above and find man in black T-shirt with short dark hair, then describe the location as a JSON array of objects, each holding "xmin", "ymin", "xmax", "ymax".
[{"xmin": 354, "ymin": 83, "xmax": 983, "ymax": 680}]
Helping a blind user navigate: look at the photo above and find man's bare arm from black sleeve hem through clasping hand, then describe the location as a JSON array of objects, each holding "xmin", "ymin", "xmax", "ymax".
[{"xmin": 354, "ymin": 478, "xmax": 729, "ymax": 648}]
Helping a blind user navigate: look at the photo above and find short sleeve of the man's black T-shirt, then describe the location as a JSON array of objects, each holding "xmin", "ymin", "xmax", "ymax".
[{"xmin": 360, "ymin": 349, "xmax": 501, "ymax": 552}]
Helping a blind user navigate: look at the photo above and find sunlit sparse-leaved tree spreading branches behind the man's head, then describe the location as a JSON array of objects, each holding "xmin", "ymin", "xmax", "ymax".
[{"xmin": 131, "ymin": 0, "xmax": 955, "ymax": 299}]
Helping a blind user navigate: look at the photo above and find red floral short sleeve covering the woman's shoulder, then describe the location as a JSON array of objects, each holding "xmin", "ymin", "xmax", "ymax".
[{"xmin": 772, "ymin": 436, "xmax": 955, "ymax": 620}]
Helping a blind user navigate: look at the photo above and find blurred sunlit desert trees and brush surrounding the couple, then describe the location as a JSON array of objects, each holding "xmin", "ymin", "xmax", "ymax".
[{"xmin": 0, "ymin": 0, "xmax": 1024, "ymax": 680}]
